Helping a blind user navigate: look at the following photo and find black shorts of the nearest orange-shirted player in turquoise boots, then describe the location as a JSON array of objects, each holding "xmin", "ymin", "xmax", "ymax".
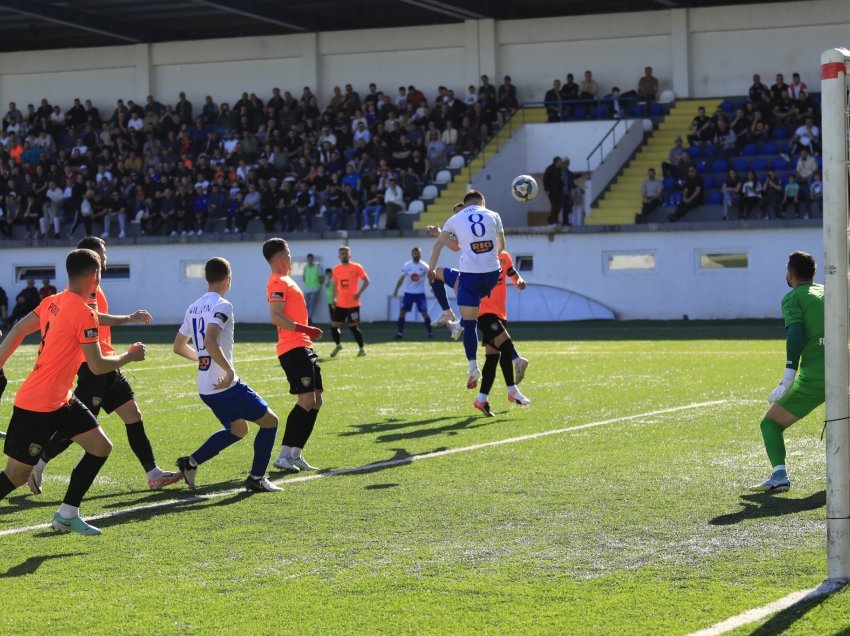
[{"xmin": 3, "ymin": 397, "xmax": 97, "ymax": 466}]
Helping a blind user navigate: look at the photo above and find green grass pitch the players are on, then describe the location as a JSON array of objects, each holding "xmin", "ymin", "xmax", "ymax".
[{"xmin": 0, "ymin": 321, "xmax": 850, "ymax": 634}]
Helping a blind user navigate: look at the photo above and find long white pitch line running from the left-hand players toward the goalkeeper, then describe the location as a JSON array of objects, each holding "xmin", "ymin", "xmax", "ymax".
[{"xmin": 0, "ymin": 400, "xmax": 730, "ymax": 537}]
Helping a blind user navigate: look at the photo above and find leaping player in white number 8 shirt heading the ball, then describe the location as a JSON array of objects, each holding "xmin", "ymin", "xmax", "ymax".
[{"xmin": 428, "ymin": 190, "xmax": 505, "ymax": 389}]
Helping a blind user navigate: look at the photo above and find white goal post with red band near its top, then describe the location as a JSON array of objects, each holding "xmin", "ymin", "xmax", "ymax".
[{"xmin": 821, "ymin": 49, "xmax": 850, "ymax": 583}]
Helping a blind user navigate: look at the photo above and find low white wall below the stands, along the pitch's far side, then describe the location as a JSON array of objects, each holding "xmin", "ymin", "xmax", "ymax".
[{"xmin": 0, "ymin": 228, "xmax": 823, "ymax": 325}]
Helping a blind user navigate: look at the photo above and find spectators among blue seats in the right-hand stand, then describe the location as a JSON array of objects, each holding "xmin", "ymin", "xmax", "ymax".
[{"xmin": 638, "ymin": 73, "xmax": 823, "ymax": 222}]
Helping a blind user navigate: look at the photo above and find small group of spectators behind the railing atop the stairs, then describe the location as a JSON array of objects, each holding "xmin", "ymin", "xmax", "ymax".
[{"xmin": 543, "ymin": 66, "xmax": 658, "ymax": 122}]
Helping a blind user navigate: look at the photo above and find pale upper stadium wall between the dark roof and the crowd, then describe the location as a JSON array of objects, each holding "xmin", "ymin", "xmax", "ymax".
[{"xmin": 0, "ymin": 0, "xmax": 850, "ymax": 112}]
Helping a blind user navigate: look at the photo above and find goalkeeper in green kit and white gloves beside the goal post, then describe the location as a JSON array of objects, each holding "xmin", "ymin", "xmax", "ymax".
[{"xmin": 750, "ymin": 252, "xmax": 825, "ymax": 493}]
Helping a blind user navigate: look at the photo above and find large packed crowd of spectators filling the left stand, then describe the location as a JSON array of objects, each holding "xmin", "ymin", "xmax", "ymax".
[{"xmin": 0, "ymin": 75, "xmax": 510, "ymax": 238}]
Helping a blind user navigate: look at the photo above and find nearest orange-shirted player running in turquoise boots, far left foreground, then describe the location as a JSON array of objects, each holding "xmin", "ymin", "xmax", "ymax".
[{"xmin": 0, "ymin": 249, "xmax": 145, "ymax": 535}]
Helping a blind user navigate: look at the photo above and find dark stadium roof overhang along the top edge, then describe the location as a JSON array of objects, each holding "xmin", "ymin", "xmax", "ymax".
[{"xmin": 0, "ymin": 0, "xmax": 800, "ymax": 51}]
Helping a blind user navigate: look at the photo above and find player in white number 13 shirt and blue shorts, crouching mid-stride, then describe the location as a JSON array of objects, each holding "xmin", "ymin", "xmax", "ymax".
[{"xmin": 173, "ymin": 257, "xmax": 280, "ymax": 492}]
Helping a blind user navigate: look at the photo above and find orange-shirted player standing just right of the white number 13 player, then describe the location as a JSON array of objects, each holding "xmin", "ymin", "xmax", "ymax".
[{"xmin": 263, "ymin": 238, "xmax": 324, "ymax": 473}]
